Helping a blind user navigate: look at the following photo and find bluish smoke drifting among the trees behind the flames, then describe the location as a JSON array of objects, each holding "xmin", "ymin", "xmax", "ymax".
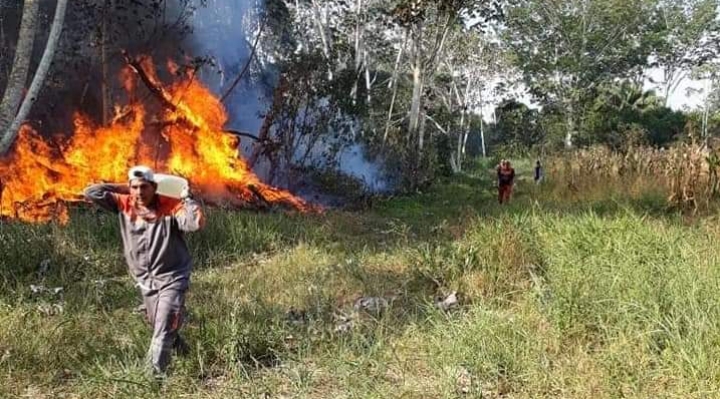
[{"xmin": 189, "ymin": 0, "xmax": 389, "ymax": 192}]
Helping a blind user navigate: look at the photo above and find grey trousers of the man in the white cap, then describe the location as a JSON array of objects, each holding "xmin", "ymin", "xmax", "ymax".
[{"xmin": 143, "ymin": 289, "xmax": 185, "ymax": 373}]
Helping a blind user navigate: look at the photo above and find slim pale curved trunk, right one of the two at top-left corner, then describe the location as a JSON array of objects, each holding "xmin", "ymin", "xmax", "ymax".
[{"xmin": 0, "ymin": 0, "xmax": 67, "ymax": 155}]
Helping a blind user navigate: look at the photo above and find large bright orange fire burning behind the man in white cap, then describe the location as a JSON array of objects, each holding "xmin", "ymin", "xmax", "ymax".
[{"xmin": 0, "ymin": 58, "xmax": 313, "ymax": 223}]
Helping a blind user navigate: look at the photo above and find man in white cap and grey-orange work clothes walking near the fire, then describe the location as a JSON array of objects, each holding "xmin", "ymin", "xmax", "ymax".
[{"xmin": 85, "ymin": 166, "xmax": 205, "ymax": 377}]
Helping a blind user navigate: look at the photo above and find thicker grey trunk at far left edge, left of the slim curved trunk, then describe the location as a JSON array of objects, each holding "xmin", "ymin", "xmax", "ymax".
[{"xmin": 0, "ymin": 0, "xmax": 40, "ymax": 134}]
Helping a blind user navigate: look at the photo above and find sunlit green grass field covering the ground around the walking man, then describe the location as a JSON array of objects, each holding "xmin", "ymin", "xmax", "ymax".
[{"xmin": 0, "ymin": 163, "xmax": 720, "ymax": 398}]
